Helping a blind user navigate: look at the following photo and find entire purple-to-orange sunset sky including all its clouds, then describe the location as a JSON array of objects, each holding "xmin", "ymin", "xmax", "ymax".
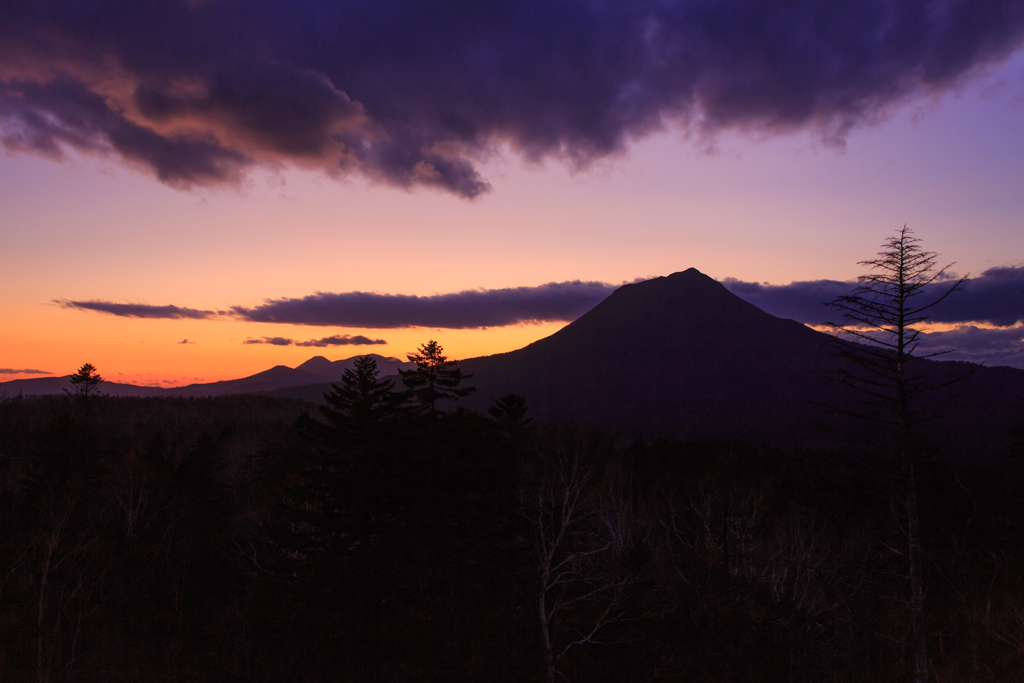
[{"xmin": 0, "ymin": 0, "xmax": 1024, "ymax": 386}]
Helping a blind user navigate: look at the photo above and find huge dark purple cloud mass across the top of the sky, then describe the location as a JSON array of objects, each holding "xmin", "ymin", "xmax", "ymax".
[{"xmin": 0, "ymin": 0, "xmax": 1024, "ymax": 198}]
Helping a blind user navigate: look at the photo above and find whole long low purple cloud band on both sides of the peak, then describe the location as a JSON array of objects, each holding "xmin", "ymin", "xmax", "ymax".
[{"xmin": 56, "ymin": 266, "xmax": 1024, "ymax": 331}]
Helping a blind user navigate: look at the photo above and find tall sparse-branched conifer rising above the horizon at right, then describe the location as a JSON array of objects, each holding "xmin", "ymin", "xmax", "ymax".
[{"xmin": 827, "ymin": 225, "xmax": 967, "ymax": 683}]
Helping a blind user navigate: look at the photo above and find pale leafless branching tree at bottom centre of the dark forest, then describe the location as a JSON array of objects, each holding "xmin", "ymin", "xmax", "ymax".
[{"xmin": 520, "ymin": 444, "xmax": 638, "ymax": 683}]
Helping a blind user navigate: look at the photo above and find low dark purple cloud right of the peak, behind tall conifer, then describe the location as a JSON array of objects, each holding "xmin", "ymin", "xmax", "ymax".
[{"xmin": 722, "ymin": 266, "xmax": 1024, "ymax": 327}]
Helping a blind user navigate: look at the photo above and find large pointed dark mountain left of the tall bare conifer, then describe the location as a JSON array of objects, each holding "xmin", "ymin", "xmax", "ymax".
[{"xmin": 461, "ymin": 268, "xmax": 834, "ymax": 441}]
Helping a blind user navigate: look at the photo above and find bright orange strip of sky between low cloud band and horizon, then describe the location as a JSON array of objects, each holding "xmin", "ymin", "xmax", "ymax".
[{"xmin": 0, "ymin": 296, "xmax": 566, "ymax": 387}]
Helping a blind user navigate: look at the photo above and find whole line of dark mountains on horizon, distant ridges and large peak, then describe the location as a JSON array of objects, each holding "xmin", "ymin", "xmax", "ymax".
[{"xmin": 0, "ymin": 268, "xmax": 1024, "ymax": 453}]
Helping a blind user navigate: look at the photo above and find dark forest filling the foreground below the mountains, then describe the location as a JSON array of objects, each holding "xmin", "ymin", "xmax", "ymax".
[{"xmin": 0, "ymin": 387, "xmax": 1024, "ymax": 683}]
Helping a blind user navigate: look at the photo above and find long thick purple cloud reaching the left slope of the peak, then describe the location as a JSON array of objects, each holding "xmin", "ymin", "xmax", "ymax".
[{"xmin": 231, "ymin": 281, "xmax": 617, "ymax": 330}]
